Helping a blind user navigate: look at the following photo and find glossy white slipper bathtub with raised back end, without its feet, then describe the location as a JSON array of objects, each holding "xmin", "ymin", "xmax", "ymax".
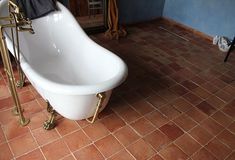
[{"xmin": 0, "ymin": 0, "xmax": 127, "ymax": 120}]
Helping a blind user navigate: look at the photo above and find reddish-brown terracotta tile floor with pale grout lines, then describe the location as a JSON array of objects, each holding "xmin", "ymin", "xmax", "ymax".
[{"xmin": 0, "ymin": 21, "xmax": 235, "ymax": 160}]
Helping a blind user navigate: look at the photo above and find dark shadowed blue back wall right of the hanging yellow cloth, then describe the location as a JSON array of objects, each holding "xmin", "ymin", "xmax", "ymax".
[{"xmin": 117, "ymin": 0, "xmax": 165, "ymax": 24}]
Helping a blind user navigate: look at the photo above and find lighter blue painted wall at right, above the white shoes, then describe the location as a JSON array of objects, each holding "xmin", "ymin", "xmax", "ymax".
[{"xmin": 163, "ymin": 0, "xmax": 235, "ymax": 39}]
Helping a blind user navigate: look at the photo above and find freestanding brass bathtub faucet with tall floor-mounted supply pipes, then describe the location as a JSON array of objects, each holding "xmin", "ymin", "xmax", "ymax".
[{"xmin": 0, "ymin": 1, "xmax": 33, "ymax": 126}]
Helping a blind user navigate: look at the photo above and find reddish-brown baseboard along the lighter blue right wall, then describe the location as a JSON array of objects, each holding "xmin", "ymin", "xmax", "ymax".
[{"xmin": 160, "ymin": 17, "xmax": 213, "ymax": 41}]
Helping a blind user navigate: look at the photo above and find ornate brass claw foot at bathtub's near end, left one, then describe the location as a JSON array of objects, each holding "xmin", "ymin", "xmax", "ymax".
[{"xmin": 43, "ymin": 101, "xmax": 57, "ymax": 130}]
